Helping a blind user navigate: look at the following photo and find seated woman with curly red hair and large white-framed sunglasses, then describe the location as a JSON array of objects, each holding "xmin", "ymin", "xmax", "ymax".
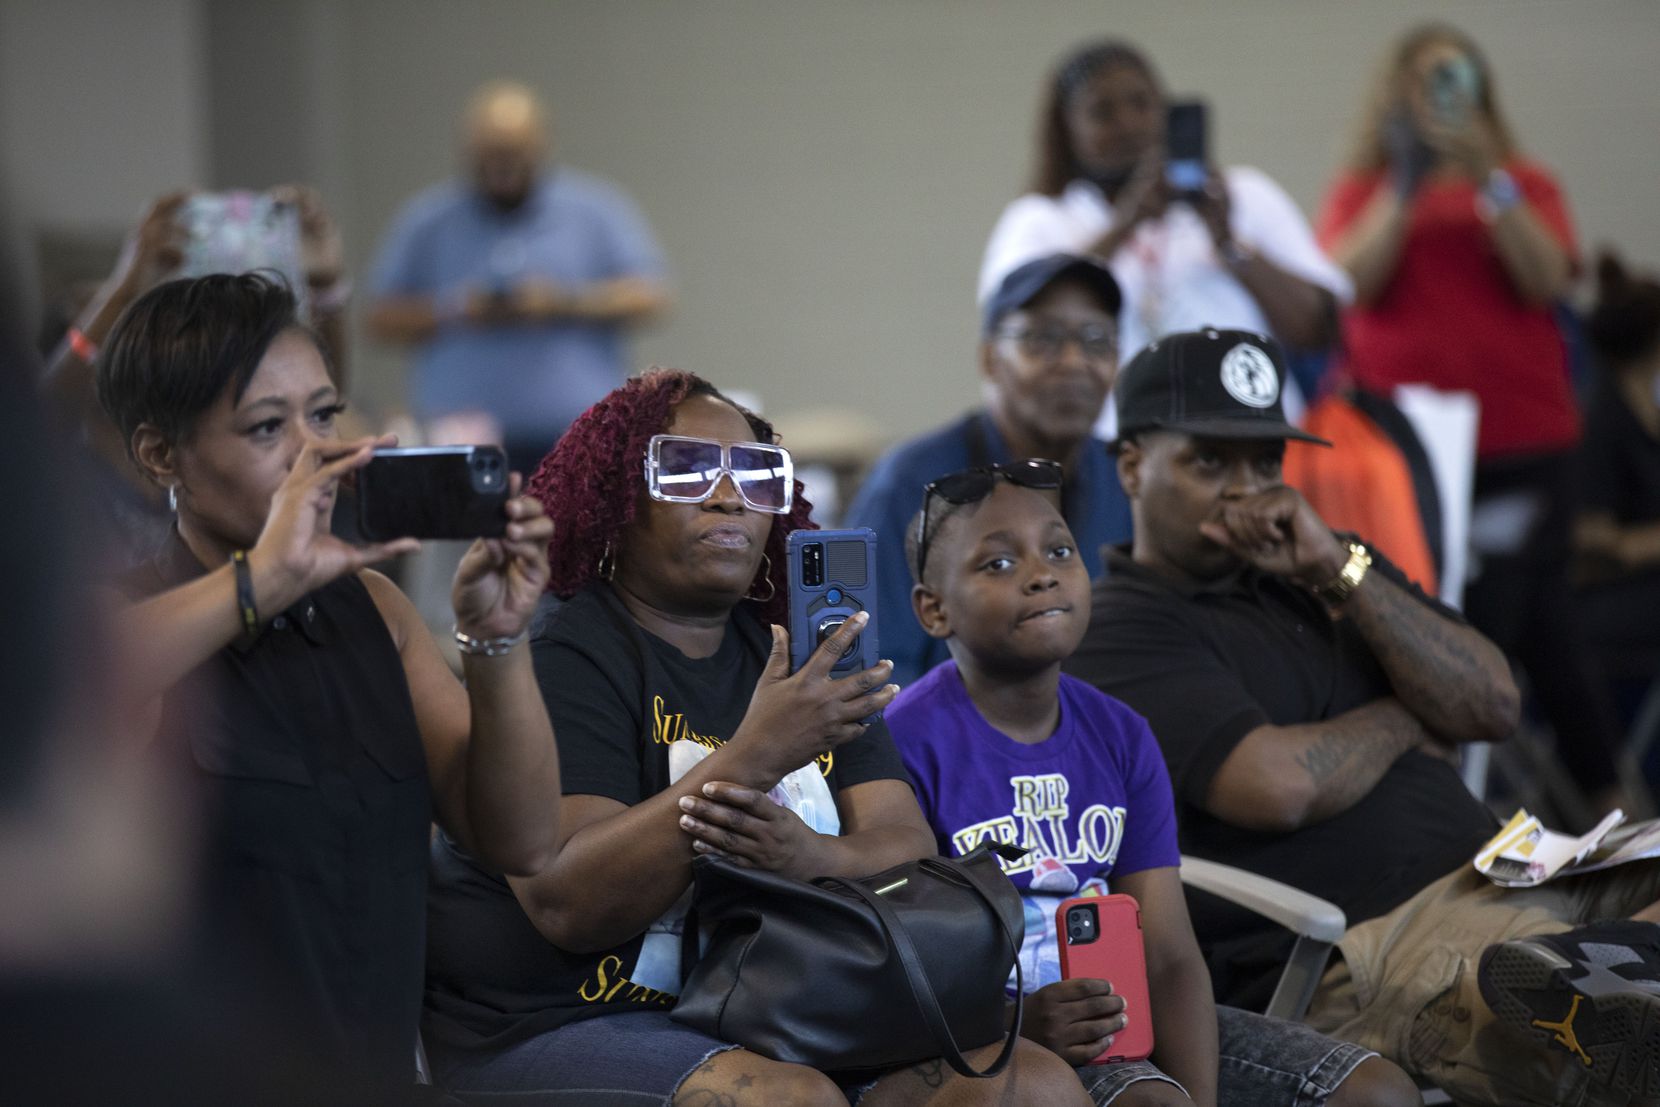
[{"xmin": 425, "ymin": 372, "xmax": 1087, "ymax": 1105}]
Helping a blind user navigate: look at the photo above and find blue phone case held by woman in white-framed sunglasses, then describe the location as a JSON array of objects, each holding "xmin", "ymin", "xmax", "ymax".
[{"xmin": 789, "ymin": 526, "xmax": 881, "ymax": 719}]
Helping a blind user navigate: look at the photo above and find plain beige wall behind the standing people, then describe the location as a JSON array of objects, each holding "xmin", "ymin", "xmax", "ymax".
[{"xmin": 0, "ymin": 0, "xmax": 1660, "ymax": 448}]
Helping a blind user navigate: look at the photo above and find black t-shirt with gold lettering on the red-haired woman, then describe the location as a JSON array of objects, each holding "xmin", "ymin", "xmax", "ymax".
[{"xmin": 415, "ymin": 586, "xmax": 908, "ymax": 1051}]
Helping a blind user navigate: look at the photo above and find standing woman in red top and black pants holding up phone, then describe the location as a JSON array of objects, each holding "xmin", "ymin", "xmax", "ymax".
[{"xmin": 1318, "ymin": 23, "xmax": 1623, "ymax": 807}]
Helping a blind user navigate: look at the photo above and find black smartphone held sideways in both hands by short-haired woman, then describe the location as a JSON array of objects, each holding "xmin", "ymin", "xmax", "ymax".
[{"xmin": 357, "ymin": 446, "xmax": 508, "ymax": 543}]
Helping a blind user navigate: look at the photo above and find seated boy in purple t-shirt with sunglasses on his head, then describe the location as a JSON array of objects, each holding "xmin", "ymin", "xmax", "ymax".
[{"xmin": 885, "ymin": 461, "xmax": 1421, "ymax": 1107}]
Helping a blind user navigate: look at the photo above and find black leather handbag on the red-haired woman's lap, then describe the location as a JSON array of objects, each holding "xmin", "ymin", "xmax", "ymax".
[{"xmin": 672, "ymin": 845, "xmax": 1026, "ymax": 1077}]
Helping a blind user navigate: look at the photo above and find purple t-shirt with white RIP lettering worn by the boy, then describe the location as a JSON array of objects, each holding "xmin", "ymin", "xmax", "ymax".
[{"xmin": 883, "ymin": 661, "xmax": 1182, "ymax": 991}]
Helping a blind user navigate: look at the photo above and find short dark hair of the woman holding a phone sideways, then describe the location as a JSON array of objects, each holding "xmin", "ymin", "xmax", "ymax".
[{"xmin": 96, "ymin": 272, "xmax": 320, "ymax": 450}]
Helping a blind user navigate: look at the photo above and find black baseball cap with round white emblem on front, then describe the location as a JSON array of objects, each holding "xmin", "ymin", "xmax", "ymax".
[{"xmin": 1112, "ymin": 327, "xmax": 1331, "ymax": 446}]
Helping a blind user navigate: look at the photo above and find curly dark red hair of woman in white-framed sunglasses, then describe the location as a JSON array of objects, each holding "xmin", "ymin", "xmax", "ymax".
[{"xmin": 526, "ymin": 368, "xmax": 818, "ymax": 624}]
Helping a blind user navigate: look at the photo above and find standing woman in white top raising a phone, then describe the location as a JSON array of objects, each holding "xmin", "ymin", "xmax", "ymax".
[{"xmin": 979, "ymin": 40, "xmax": 1350, "ymax": 424}]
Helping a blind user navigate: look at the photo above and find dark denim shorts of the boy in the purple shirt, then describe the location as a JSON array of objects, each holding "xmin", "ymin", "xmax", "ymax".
[{"xmin": 1077, "ymin": 1007, "xmax": 1378, "ymax": 1107}]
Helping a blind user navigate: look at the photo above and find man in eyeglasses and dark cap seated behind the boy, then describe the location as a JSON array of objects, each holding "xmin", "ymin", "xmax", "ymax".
[{"xmin": 845, "ymin": 254, "xmax": 1130, "ymax": 685}]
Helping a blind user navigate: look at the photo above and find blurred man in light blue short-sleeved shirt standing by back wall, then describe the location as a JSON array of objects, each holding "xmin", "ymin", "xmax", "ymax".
[{"xmin": 369, "ymin": 83, "xmax": 667, "ymax": 471}]
